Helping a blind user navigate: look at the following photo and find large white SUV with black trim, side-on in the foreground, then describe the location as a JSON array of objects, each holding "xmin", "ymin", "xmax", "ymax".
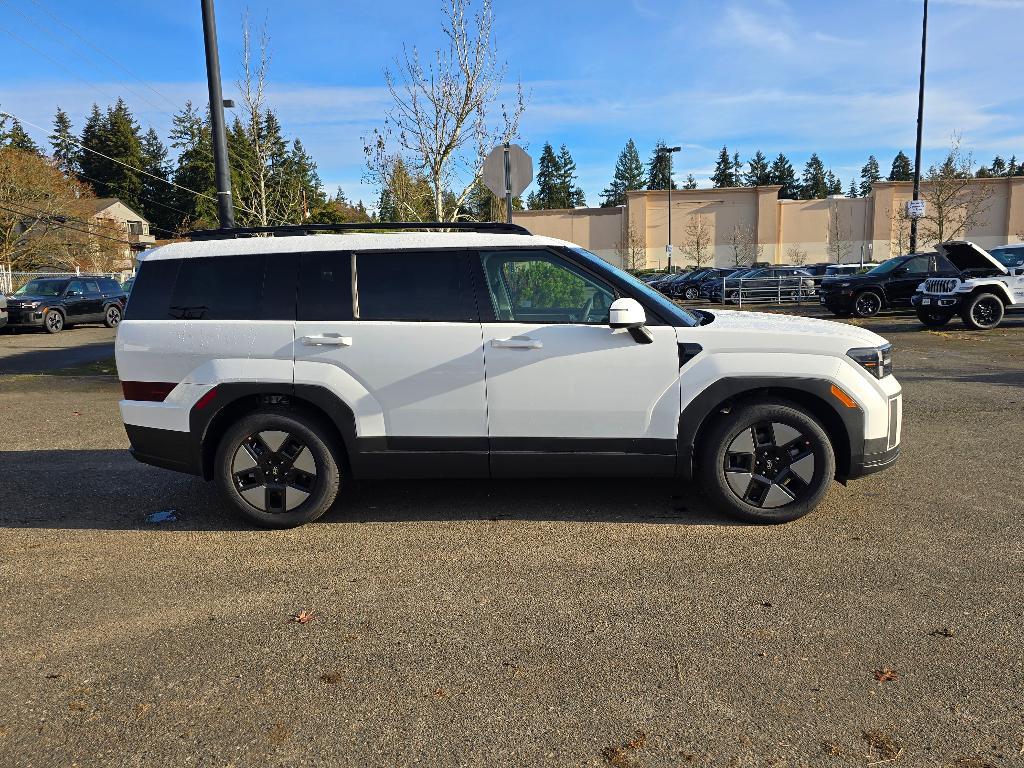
[{"xmin": 117, "ymin": 224, "xmax": 901, "ymax": 527}]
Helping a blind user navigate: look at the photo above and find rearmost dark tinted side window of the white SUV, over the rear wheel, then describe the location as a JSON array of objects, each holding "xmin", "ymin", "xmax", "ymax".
[{"xmin": 125, "ymin": 254, "xmax": 298, "ymax": 321}]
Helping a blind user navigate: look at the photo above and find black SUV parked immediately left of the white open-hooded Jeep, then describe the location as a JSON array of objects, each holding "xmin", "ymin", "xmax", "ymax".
[{"xmin": 820, "ymin": 253, "xmax": 959, "ymax": 317}]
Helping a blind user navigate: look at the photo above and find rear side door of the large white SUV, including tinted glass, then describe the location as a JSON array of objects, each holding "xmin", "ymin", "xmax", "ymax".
[{"xmin": 295, "ymin": 250, "xmax": 487, "ymax": 477}]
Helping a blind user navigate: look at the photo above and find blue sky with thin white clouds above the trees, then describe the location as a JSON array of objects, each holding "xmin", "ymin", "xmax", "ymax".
[{"xmin": 0, "ymin": 0, "xmax": 1024, "ymax": 205}]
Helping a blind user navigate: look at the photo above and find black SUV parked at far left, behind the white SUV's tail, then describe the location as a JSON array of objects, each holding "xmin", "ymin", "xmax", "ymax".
[{"xmin": 7, "ymin": 275, "xmax": 128, "ymax": 334}]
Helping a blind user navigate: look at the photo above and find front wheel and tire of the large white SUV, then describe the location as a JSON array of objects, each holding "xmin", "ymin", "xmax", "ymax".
[{"xmin": 697, "ymin": 400, "xmax": 836, "ymax": 523}]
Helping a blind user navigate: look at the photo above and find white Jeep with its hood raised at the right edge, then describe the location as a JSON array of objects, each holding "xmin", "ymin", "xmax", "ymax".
[{"xmin": 911, "ymin": 240, "xmax": 1024, "ymax": 331}]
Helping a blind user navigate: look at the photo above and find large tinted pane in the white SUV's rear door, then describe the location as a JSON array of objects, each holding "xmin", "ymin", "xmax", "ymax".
[{"xmin": 355, "ymin": 251, "xmax": 477, "ymax": 323}]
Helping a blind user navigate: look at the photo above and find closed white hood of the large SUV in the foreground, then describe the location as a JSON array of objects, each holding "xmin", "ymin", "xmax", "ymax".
[{"xmin": 700, "ymin": 309, "xmax": 888, "ymax": 353}]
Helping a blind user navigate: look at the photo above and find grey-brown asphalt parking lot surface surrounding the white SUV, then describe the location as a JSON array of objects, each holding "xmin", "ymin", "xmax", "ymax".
[{"xmin": 0, "ymin": 309, "xmax": 1024, "ymax": 768}]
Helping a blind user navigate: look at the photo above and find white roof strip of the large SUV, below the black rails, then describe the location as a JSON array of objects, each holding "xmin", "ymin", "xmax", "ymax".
[{"xmin": 138, "ymin": 231, "xmax": 578, "ymax": 261}]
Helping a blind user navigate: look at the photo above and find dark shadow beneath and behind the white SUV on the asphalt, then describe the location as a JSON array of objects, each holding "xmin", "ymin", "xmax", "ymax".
[{"xmin": 0, "ymin": 450, "xmax": 743, "ymax": 530}]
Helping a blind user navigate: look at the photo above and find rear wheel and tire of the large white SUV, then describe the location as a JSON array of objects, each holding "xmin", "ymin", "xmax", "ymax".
[{"xmin": 214, "ymin": 411, "xmax": 341, "ymax": 528}]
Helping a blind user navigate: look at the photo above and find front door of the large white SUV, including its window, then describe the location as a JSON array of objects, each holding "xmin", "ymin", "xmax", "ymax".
[{"xmin": 478, "ymin": 249, "xmax": 679, "ymax": 476}]
